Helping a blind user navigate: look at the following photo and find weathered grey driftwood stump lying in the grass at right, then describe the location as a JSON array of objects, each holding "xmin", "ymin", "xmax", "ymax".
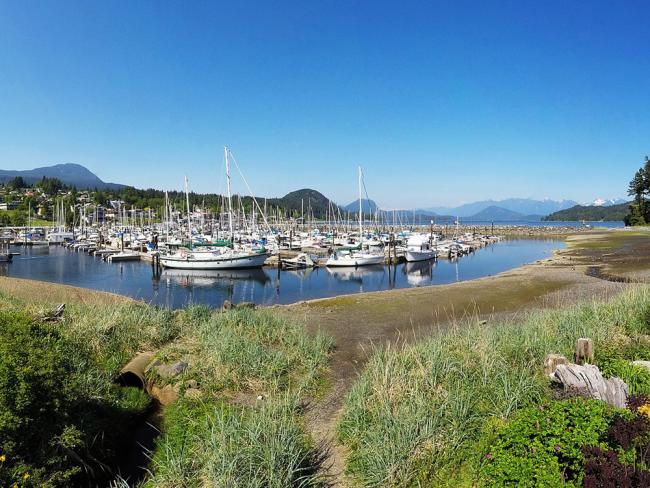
[{"xmin": 551, "ymin": 364, "xmax": 629, "ymax": 408}]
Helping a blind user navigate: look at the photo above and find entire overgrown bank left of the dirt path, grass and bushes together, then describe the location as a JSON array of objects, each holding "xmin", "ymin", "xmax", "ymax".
[{"xmin": 0, "ymin": 293, "xmax": 331, "ymax": 487}]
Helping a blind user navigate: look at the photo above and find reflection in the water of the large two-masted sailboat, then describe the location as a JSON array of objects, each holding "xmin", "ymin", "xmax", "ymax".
[{"xmin": 160, "ymin": 268, "xmax": 270, "ymax": 288}]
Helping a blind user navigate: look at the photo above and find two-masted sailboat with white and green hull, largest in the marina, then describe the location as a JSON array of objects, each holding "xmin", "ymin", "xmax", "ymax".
[{"xmin": 160, "ymin": 147, "xmax": 269, "ymax": 269}]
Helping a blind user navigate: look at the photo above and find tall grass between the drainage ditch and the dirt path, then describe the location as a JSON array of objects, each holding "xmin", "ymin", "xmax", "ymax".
[{"xmin": 147, "ymin": 308, "xmax": 332, "ymax": 488}]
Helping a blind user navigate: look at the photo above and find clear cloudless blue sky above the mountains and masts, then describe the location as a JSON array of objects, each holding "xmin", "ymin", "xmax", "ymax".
[{"xmin": 0, "ymin": 0, "xmax": 650, "ymax": 208}]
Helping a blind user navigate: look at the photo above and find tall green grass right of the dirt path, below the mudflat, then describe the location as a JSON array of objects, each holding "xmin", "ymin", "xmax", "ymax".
[{"xmin": 338, "ymin": 287, "xmax": 650, "ymax": 486}]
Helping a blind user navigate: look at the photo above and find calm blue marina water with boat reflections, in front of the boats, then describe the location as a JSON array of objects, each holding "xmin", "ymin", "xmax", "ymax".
[{"xmin": 0, "ymin": 239, "xmax": 564, "ymax": 308}]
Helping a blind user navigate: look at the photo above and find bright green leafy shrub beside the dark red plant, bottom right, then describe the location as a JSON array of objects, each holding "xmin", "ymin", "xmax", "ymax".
[{"xmin": 481, "ymin": 398, "xmax": 615, "ymax": 487}]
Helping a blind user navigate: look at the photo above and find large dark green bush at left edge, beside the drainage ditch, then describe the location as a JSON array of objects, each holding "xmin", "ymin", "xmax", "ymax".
[{"xmin": 0, "ymin": 308, "xmax": 150, "ymax": 486}]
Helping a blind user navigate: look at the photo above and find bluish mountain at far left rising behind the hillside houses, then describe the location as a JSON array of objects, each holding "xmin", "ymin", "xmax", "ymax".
[{"xmin": 0, "ymin": 163, "xmax": 125, "ymax": 190}]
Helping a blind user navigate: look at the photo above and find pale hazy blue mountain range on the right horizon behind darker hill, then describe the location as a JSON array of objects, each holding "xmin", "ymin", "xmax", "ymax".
[{"xmin": 421, "ymin": 198, "xmax": 578, "ymax": 220}]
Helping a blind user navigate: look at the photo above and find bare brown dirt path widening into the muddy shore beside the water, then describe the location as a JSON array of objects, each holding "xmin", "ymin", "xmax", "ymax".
[{"xmin": 278, "ymin": 230, "xmax": 650, "ymax": 486}]
